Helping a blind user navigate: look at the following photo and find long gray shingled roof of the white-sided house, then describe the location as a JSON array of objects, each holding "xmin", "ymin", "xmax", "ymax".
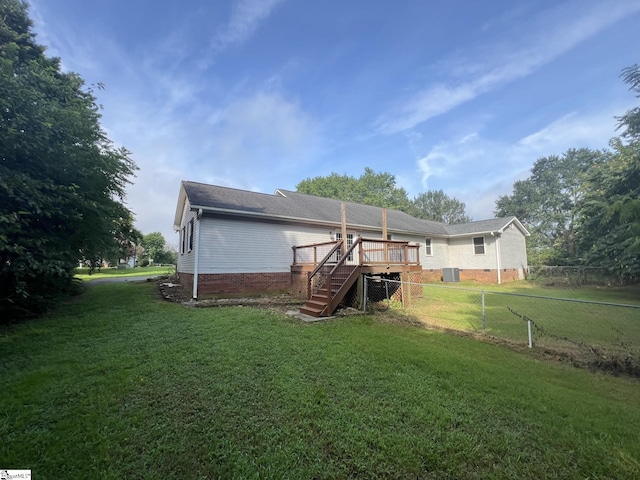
[{"xmin": 182, "ymin": 181, "xmax": 514, "ymax": 236}]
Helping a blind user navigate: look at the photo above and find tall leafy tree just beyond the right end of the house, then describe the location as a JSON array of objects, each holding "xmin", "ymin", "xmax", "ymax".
[{"xmin": 494, "ymin": 148, "xmax": 609, "ymax": 264}]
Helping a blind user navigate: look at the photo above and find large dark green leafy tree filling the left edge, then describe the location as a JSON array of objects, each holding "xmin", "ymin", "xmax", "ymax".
[{"xmin": 0, "ymin": 0, "xmax": 136, "ymax": 318}]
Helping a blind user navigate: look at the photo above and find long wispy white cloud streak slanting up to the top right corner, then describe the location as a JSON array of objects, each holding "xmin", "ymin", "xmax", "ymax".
[{"xmin": 375, "ymin": 2, "xmax": 640, "ymax": 134}]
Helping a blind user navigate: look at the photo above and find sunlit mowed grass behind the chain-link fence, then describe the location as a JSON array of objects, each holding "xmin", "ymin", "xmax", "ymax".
[{"xmin": 408, "ymin": 282, "xmax": 640, "ymax": 365}]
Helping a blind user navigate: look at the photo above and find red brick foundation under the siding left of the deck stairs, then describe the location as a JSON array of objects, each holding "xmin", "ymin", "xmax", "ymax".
[{"xmin": 179, "ymin": 272, "xmax": 291, "ymax": 296}]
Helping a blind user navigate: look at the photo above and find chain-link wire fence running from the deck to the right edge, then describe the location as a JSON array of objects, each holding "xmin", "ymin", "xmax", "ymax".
[{"xmin": 364, "ymin": 277, "xmax": 640, "ymax": 376}]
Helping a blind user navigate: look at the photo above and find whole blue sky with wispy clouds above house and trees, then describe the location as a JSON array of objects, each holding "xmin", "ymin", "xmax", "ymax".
[{"xmin": 29, "ymin": 0, "xmax": 640, "ymax": 244}]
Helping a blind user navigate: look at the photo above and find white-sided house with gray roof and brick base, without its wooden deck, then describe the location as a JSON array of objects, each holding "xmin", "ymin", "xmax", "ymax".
[{"xmin": 174, "ymin": 181, "xmax": 529, "ymax": 298}]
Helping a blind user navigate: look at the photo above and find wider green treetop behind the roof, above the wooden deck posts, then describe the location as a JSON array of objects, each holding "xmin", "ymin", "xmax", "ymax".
[{"xmin": 296, "ymin": 167, "xmax": 410, "ymax": 212}]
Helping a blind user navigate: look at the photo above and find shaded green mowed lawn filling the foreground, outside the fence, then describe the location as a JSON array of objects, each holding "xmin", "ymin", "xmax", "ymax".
[{"xmin": 0, "ymin": 284, "xmax": 640, "ymax": 479}]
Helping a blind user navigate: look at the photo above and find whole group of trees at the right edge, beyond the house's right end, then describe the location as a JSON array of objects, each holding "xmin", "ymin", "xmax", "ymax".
[{"xmin": 494, "ymin": 64, "xmax": 640, "ymax": 282}]
